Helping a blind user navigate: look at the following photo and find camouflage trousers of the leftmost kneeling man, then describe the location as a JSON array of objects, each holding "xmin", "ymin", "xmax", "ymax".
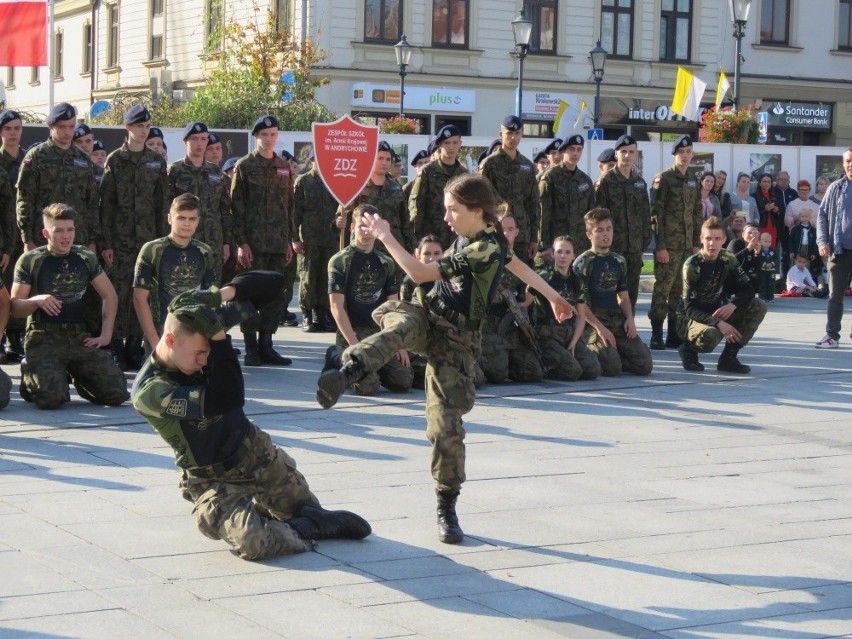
[{"xmin": 21, "ymin": 324, "xmax": 130, "ymax": 408}]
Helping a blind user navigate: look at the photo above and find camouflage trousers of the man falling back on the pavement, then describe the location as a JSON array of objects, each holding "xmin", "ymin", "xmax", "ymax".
[{"xmin": 181, "ymin": 424, "xmax": 319, "ymax": 560}]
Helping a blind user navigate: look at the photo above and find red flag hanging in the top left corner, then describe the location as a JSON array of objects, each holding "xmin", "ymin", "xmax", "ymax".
[{"xmin": 0, "ymin": 0, "xmax": 47, "ymax": 67}]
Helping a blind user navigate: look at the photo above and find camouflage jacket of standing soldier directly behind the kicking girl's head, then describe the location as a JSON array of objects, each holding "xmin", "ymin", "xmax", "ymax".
[{"xmin": 408, "ymin": 160, "xmax": 467, "ymax": 248}]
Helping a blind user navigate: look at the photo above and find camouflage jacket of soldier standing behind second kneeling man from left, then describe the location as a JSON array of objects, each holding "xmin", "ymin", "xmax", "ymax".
[{"xmin": 168, "ymin": 157, "xmax": 234, "ymax": 256}]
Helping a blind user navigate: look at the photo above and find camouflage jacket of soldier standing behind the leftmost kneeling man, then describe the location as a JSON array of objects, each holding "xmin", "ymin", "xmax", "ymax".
[{"xmin": 17, "ymin": 140, "xmax": 101, "ymax": 245}]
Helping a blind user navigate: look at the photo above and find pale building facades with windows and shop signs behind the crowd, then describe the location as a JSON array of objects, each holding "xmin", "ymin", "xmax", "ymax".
[{"xmin": 5, "ymin": 0, "xmax": 852, "ymax": 145}]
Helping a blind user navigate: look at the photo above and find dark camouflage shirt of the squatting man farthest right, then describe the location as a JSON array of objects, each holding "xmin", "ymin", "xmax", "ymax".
[{"xmin": 682, "ymin": 249, "xmax": 754, "ymax": 326}]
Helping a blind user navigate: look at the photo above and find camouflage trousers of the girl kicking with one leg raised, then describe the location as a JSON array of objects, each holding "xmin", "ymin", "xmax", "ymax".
[{"xmin": 343, "ymin": 294, "xmax": 480, "ymax": 492}]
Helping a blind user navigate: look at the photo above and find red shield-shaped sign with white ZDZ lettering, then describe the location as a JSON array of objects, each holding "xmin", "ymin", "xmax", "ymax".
[{"xmin": 313, "ymin": 115, "xmax": 379, "ymax": 206}]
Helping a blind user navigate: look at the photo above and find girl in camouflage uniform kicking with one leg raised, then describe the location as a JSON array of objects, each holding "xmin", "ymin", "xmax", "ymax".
[{"xmin": 317, "ymin": 174, "xmax": 574, "ymax": 543}]
